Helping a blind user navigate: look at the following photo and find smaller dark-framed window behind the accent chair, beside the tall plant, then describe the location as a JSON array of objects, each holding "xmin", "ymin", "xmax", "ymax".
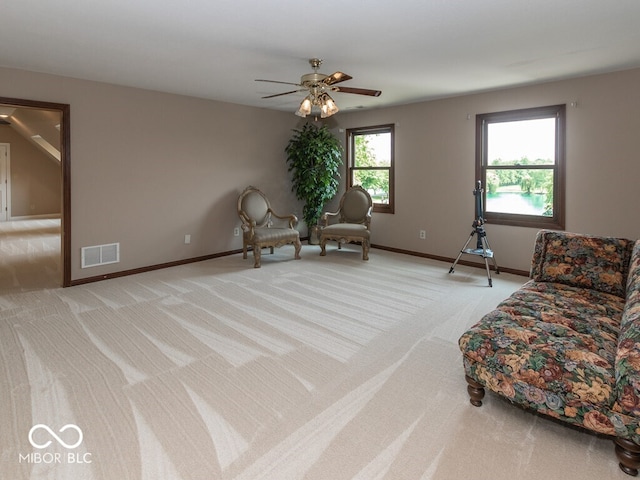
[{"xmin": 347, "ymin": 125, "xmax": 394, "ymax": 213}]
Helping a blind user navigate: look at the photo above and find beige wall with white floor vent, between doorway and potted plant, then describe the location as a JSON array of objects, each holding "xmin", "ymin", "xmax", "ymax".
[{"xmin": 0, "ymin": 68, "xmax": 301, "ymax": 280}]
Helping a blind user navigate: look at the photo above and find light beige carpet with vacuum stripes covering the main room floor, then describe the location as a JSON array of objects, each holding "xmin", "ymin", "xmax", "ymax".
[{"xmin": 0, "ymin": 223, "xmax": 626, "ymax": 480}]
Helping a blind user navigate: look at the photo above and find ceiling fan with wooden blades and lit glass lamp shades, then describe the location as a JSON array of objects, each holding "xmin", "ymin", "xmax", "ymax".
[{"xmin": 256, "ymin": 58, "xmax": 382, "ymax": 118}]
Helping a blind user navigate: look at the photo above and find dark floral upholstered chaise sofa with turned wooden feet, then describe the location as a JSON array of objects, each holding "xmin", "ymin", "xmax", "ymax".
[{"xmin": 459, "ymin": 230, "xmax": 640, "ymax": 476}]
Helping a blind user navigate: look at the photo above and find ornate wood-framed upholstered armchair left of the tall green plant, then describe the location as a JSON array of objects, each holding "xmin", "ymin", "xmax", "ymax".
[{"xmin": 238, "ymin": 186, "xmax": 302, "ymax": 268}]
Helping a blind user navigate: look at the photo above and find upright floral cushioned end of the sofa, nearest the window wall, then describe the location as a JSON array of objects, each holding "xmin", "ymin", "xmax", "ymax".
[{"xmin": 531, "ymin": 230, "xmax": 634, "ymax": 297}]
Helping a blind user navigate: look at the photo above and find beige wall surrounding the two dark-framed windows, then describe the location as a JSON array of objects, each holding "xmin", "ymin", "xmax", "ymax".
[{"xmin": 335, "ymin": 69, "xmax": 640, "ymax": 271}]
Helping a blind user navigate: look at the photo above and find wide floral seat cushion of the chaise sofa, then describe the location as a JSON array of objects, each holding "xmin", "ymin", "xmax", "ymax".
[{"xmin": 459, "ymin": 281, "xmax": 624, "ymax": 418}]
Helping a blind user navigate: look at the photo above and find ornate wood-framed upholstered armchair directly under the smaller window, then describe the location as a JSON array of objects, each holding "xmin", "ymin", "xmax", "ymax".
[{"xmin": 320, "ymin": 185, "xmax": 373, "ymax": 260}]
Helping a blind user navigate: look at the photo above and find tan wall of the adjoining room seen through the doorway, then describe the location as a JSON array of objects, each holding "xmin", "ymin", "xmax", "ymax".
[{"xmin": 0, "ymin": 125, "xmax": 62, "ymax": 218}]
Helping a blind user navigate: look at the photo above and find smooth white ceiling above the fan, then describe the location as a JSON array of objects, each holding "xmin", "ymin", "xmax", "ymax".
[{"xmin": 0, "ymin": 0, "xmax": 640, "ymax": 111}]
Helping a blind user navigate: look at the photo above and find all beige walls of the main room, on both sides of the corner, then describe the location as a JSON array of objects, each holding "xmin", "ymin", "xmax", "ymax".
[{"xmin": 0, "ymin": 64, "xmax": 640, "ymax": 280}]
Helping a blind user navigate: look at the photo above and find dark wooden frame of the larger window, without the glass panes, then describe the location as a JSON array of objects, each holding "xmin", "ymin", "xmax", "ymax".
[{"xmin": 476, "ymin": 104, "xmax": 566, "ymax": 230}]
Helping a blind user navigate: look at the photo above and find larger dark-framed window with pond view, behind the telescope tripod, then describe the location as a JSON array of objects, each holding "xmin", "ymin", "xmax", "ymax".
[{"xmin": 476, "ymin": 105, "xmax": 565, "ymax": 230}]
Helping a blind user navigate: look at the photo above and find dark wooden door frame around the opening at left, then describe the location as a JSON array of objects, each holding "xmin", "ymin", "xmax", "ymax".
[{"xmin": 0, "ymin": 97, "xmax": 71, "ymax": 287}]
